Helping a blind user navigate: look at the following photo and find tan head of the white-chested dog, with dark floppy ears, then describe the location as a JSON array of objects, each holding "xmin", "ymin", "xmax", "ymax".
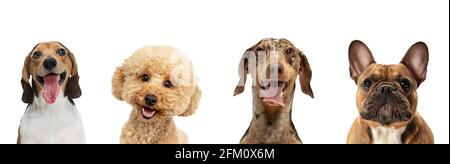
[{"xmin": 21, "ymin": 42, "xmax": 81, "ymax": 104}]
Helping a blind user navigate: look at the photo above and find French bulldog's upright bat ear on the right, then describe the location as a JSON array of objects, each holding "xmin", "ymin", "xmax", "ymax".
[{"xmin": 400, "ymin": 42, "xmax": 429, "ymax": 87}]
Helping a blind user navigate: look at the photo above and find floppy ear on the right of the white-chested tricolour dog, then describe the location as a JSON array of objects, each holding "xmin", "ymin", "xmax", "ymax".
[{"xmin": 58, "ymin": 42, "xmax": 82, "ymax": 99}]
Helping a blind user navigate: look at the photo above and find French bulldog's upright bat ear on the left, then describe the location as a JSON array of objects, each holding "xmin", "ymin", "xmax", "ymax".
[{"xmin": 348, "ymin": 40, "xmax": 376, "ymax": 83}]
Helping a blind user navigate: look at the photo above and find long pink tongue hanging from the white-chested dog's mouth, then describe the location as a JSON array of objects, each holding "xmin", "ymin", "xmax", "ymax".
[{"xmin": 42, "ymin": 75, "xmax": 60, "ymax": 104}]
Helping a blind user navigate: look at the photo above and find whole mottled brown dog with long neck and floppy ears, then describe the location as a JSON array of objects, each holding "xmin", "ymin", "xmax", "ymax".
[{"xmin": 234, "ymin": 38, "xmax": 314, "ymax": 144}]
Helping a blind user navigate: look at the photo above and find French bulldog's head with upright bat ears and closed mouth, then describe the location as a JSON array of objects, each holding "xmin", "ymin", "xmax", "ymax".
[{"xmin": 349, "ymin": 41, "xmax": 428, "ymax": 126}]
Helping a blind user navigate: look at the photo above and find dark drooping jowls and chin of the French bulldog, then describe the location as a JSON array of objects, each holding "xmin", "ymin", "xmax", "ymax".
[{"xmin": 360, "ymin": 97, "xmax": 413, "ymax": 126}]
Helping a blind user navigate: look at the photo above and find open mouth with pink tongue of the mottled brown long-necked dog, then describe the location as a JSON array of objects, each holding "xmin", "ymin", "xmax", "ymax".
[{"xmin": 260, "ymin": 81, "xmax": 290, "ymax": 107}]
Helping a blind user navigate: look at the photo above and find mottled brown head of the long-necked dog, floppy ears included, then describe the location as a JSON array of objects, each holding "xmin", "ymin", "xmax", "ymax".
[{"xmin": 234, "ymin": 38, "xmax": 314, "ymax": 108}]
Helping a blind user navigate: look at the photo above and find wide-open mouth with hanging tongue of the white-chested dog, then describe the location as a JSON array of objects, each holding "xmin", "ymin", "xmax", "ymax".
[{"xmin": 37, "ymin": 72, "xmax": 67, "ymax": 104}]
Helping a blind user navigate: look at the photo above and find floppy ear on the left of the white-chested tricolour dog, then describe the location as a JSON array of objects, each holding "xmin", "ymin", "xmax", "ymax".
[{"xmin": 20, "ymin": 55, "xmax": 34, "ymax": 104}]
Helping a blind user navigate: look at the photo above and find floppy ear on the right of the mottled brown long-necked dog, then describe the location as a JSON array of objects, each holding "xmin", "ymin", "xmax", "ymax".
[{"xmin": 298, "ymin": 51, "xmax": 314, "ymax": 98}]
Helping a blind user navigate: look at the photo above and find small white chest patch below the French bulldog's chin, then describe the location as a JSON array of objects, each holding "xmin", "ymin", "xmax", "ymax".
[{"xmin": 371, "ymin": 126, "xmax": 406, "ymax": 144}]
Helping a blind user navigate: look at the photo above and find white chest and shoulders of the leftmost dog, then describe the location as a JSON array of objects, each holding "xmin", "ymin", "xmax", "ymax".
[{"xmin": 20, "ymin": 92, "xmax": 85, "ymax": 144}]
